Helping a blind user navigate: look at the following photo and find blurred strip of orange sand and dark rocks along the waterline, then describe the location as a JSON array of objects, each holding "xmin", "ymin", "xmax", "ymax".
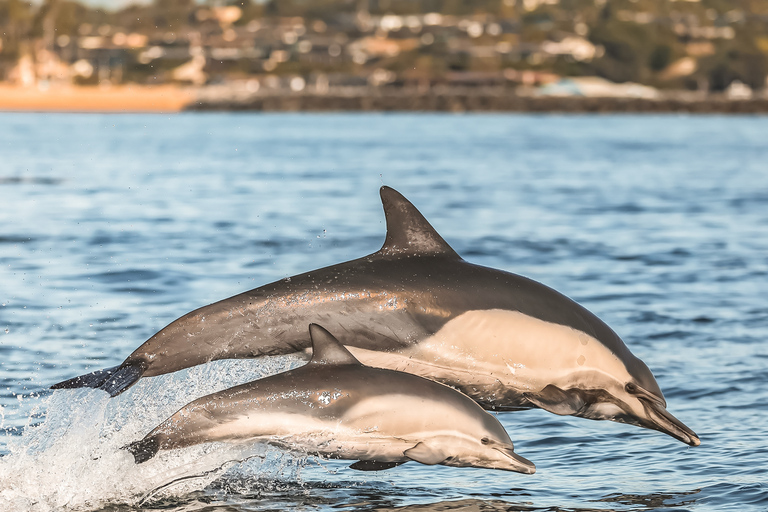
[{"xmin": 0, "ymin": 85, "xmax": 768, "ymax": 114}]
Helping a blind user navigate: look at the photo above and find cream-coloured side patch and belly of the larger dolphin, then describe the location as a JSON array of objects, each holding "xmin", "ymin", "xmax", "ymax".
[{"xmin": 347, "ymin": 309, "xmax": 630, "ymax": 393}]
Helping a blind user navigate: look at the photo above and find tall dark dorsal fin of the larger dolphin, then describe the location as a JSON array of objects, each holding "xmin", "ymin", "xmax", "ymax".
[{"xmin": 379, "ymin": 186, "xmax": 461, "ymax": 259}]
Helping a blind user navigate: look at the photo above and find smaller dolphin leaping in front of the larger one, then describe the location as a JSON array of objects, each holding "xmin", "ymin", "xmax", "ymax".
[{"xmin": 126, "ymin": 324, "xmax": 536, "ymax": 474}]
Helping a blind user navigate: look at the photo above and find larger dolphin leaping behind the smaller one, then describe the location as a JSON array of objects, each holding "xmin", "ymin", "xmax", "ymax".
[{"xmin": 53, "ymin": 187, "xmax": 700, "ymax": 446}]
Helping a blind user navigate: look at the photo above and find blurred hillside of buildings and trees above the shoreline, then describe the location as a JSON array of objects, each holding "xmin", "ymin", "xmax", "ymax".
[{"xmin": 0, "ymin": 0, "xmax": 768, "ymax": 104}]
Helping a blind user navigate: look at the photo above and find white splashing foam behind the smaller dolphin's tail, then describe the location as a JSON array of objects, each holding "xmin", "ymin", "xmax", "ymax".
[{"xmin": 0, "ymin": 356, "xmax": 301, "ymax": 512}]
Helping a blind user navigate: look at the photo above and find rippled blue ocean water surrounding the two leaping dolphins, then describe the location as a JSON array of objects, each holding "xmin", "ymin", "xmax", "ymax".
[{"xmin": 0, "ymin": 114, "xmax": 768, "ymax": 512}]
